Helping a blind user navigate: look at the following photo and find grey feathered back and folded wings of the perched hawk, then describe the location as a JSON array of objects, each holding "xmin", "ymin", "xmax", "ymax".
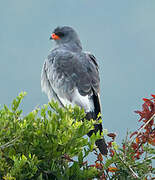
[{"xmin": 42, "ymin": 50, "xmax": 99, "ymax": 111}]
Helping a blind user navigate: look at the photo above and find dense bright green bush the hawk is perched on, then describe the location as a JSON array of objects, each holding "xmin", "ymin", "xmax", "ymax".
[{"xmin": 0, "ymin": 93, "xmax": 99, "ymax": 180}]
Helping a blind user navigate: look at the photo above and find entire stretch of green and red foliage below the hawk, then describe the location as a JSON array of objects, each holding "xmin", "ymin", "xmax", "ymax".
[{"xmin": 0, "ymin": 93, "xmax": 155, "ymax": 180}]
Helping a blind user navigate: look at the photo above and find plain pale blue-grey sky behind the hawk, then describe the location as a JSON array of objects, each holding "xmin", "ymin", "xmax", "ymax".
[{"xmin": 0, "ymin": 0, "xmax": 155, "ymax": 155}]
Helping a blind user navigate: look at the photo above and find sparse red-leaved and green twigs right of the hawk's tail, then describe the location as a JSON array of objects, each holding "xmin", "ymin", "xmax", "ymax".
[{"xmin": 87, "ymin": 95, "xmax": 155, "ymax": 180}]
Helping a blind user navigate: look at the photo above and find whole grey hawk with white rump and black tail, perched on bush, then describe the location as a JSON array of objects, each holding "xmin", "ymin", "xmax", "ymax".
[{"xmin": 41, "ymin": 26, "xmax": 108, "ymax": 155}]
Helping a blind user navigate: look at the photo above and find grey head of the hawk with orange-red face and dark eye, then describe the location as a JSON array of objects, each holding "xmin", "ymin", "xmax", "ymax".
[{"xmin": 50, "ymin": 26, "xmax": 81, "ymax": 46}]
